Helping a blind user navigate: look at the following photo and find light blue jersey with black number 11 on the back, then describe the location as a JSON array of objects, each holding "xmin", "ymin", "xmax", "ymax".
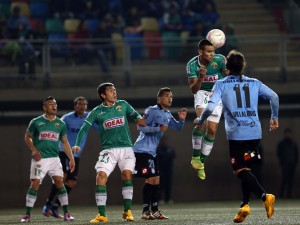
[{"xmin": 199, "ymin": 75, "xmax": 279, "ymax": 140}]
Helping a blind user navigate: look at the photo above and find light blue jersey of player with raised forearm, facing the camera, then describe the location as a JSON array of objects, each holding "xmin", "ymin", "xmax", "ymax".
[{"xmin": 133, "ymin": 105, "xmax": 184, "ymax": 157}]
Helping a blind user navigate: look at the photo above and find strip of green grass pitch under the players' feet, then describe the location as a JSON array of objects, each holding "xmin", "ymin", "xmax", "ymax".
[{"xmin": 0, "ymin": 200, "xmax": 300, "ymax": 225}]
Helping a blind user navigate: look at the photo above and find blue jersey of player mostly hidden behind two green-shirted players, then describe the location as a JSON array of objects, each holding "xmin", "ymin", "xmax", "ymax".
[{"xmin": 59, "ymin": 111, "xmax": 98, "ymax": 157}]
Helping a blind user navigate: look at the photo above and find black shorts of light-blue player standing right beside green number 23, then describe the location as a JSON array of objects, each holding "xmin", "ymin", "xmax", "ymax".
[{"xmin": 134, "ymin": 153, "xmax": 159, "ymax": 178}]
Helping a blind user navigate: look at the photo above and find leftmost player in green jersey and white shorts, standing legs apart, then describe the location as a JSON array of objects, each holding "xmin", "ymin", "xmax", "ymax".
[{"xmin": 21, "ymin": 96, "xmax": 76, "ymax": 223}]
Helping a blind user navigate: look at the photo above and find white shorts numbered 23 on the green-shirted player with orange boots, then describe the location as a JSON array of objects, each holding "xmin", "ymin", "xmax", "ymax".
[{"xmin": 95, "ymin": 147, "xmax": 135, "ymax": 177}]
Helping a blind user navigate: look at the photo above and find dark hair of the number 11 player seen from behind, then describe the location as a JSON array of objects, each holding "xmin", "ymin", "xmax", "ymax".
[{"xmin": 226, "ymin": 50, "xmax": 246, "ymax": 81}]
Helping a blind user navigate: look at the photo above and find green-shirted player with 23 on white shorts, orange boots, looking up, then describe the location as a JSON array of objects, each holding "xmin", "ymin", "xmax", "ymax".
[{"xmin": 73, "ymin": 83, "xmax": 146, "ymax": 223}]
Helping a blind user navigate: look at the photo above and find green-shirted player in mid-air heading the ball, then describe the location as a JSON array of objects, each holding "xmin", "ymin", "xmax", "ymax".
[{"xmin": 186, "ymin": 39, "xmax": 226, "ymax": 180}]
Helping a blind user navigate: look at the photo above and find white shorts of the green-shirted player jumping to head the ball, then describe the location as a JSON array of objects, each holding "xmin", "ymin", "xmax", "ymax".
[{"xmin": 194, "ymin": 90, "xmax": 223, "ymax": 123}]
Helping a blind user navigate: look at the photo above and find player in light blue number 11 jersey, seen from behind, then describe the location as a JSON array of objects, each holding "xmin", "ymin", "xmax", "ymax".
[{"xmin": 194, "ymin": 50, "xmax": 279, "ymax": 223}]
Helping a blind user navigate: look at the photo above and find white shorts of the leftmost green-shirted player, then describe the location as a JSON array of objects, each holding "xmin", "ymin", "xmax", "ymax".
[{"xmin": 30, "ymin": 157, "xmax": 64, "ymax": 183}]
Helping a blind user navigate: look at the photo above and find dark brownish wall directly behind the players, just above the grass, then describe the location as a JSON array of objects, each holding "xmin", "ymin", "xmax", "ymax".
[{"xmin": 0, "ymin": 118, "xmax": 300, "ymax": 208}]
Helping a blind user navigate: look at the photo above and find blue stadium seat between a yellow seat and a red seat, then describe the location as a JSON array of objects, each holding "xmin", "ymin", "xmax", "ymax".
[{"xmin": 124, "ymin": 33, "xmax": 143, "ymax": 60}]
